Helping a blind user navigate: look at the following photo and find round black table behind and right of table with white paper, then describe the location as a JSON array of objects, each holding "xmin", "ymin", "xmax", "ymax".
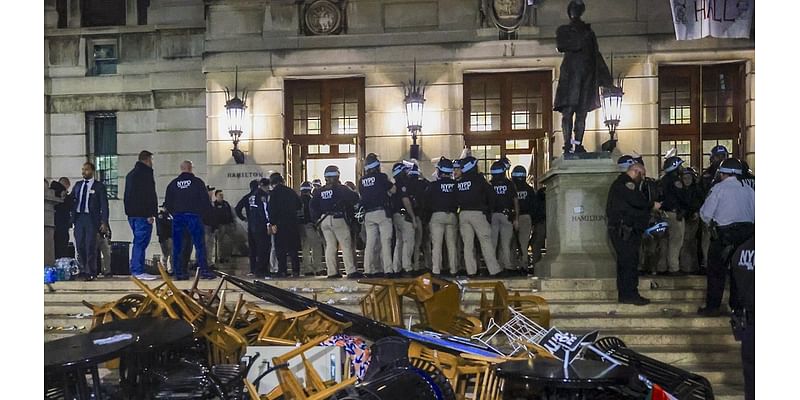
[{"xmin": 92, "ymin": 317, "xmax": 194, "ymax": 398}]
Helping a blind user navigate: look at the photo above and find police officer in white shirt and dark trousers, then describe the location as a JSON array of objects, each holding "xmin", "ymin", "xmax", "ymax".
[{"xmin": 697, "ymin": 158, "xmax": 756, "ymax": 316}]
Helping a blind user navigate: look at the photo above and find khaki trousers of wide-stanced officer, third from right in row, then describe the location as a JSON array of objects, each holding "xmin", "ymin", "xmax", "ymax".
[{"xmin": 458, "ymin": 210, "xmax": 502, "ymax": 275}]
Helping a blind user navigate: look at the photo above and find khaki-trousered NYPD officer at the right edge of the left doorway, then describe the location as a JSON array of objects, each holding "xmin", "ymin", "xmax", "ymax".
[{"xmin": 358, "ymin": 153, "xmax": 393, "ymax": 278}]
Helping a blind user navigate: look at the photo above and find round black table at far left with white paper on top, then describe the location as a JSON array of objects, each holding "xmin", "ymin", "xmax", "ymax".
[{"xmin": 44, "ymin": 331, "xmax": 139, "ymax": 399}]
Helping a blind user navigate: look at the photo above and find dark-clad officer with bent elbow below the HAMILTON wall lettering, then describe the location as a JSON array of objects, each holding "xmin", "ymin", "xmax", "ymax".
[{"xmin": 235, "ymin": 179, "xmax": 272, "ymax": 276}]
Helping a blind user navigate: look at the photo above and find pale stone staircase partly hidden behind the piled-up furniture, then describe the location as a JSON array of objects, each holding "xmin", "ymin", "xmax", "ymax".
[{"xmin": 44, "ymin": 268, "xmax": 744, "ymax": 400}]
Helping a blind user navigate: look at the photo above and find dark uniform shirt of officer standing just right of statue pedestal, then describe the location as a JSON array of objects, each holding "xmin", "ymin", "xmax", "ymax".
[{"xmin": 606, "ymin": 173, "xmax": 653, "ymax": 231}]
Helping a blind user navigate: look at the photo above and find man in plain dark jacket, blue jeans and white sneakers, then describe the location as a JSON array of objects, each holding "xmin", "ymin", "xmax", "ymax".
[{"xmin": 123, "ymin": 150, "xmax": 158, "ymax": 281}]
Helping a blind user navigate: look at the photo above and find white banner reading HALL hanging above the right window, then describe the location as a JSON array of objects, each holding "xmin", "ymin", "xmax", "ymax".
[{"xmin": 670, "ymin": 0, "xmax": 755, "ymax": 40}]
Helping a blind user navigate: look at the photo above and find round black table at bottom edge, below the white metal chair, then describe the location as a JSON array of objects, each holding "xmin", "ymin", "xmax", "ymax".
[{"xmin": 495, "ymin": 358, "xmax": 636, "ymax": 399}]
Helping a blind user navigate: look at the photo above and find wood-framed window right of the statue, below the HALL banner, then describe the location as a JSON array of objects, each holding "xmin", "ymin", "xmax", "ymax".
[{"xmin": 658, "ymin": 63, "xmax": 744, "ymax": 168}]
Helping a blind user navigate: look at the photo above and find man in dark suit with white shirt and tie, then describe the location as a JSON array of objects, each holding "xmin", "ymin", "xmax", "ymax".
[{"xmin": 70, "ymin": 161, "xmax": 108, "ymax": 281}]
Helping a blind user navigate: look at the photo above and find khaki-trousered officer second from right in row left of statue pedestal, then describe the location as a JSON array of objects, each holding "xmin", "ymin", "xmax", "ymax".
[{"xmin": 490, "ymin": 161, "xmax": 519, "ymax": 270}]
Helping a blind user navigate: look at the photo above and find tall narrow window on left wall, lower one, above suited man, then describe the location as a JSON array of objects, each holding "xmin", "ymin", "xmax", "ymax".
[{"xmin": 86, "ymin": 112, "xmax": 119, "ymax": 199}]
